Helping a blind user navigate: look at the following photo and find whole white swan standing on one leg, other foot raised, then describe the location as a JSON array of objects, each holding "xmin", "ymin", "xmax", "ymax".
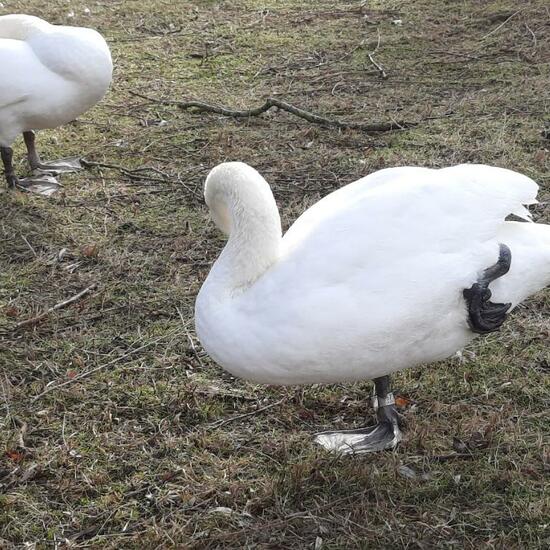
[{"xmin": 195, "ymin": 162, "xmax": 550, "ymax": 453}]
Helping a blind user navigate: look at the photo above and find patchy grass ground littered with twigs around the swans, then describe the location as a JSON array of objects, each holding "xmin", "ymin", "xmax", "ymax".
[{"xmin": 0, "ymin": 0, "xmax": 550, "ymax": 550}]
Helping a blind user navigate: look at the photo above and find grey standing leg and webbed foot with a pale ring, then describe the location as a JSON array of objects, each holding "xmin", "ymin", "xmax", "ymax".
[{"xmin": 315, "ymin": 376, "xmax": 403, "ymax": 454}]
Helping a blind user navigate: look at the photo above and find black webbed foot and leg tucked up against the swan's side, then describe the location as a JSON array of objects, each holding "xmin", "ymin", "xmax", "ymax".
[{"xmin": 463, "ymin": 244, "xmax": 512, "ymax": 334}]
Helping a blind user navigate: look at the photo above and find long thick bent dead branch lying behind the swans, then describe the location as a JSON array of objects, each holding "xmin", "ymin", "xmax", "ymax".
[{"xmin": 130, "ymin": 91, "xmax": 416, "ymax": 133}]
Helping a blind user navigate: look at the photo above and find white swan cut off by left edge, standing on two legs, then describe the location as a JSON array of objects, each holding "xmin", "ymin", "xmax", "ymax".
[{"xmin": 0, "ymin": 15, "xmax": 113, "ymax": 194}]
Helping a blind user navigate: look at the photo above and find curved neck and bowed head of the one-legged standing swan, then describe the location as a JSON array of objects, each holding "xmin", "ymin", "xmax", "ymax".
[{"xmin": 205, "ymin": 162, "xmax": 282, "ymax": 295}]
